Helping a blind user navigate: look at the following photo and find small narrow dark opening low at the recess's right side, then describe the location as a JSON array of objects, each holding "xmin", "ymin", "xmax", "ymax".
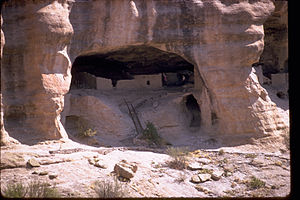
[{"xmin": 185, "ymin": 94, "xmax": 201, "ymax": 127}]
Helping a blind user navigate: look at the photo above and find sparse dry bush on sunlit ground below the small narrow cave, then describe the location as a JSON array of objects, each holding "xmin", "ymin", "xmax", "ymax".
[{"xmin": 167, "ymin": 147, "xmax": 189, "ymax": 170}]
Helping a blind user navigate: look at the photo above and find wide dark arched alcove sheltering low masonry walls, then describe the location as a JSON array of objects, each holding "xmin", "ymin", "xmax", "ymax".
[{"xmin": 71, "ymin": 45, "xmax": 194, "ymax": 90}]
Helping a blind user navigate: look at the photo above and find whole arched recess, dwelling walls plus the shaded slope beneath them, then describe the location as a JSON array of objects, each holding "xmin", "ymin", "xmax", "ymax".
[{"xmin": 62, "ymin": 45, "xmax": 201, "ymax": 144}]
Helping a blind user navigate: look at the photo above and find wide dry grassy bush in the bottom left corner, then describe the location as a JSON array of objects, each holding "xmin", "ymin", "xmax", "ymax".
[{"xmin": 3, "ymin": 181, "xmax": 60, "ymax": 198}]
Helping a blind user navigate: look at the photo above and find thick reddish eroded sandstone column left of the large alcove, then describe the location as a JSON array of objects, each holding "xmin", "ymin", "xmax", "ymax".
[{"xmin": 1, "ymin": 0, "xmax": 73, "ymax": 141}]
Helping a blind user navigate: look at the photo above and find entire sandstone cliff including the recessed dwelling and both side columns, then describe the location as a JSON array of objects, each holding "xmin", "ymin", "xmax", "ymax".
[{"xmin": 1, "ymin": 0, "xmax": 289, "ymax": 146}]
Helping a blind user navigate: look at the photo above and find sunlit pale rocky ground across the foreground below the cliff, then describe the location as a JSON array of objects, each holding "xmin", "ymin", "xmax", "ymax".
[{"xmin": 1, "ymin": 140, "xmax": 291, "ymax": 198}]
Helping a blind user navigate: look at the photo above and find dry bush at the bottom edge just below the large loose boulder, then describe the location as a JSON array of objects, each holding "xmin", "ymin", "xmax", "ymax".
[{"xmin": 94, "ymin": 178, "xmax": 125, "ymax": 198}]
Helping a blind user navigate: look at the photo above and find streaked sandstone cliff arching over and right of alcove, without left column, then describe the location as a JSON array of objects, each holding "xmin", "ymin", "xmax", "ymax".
[{"xmin": 70, "ymin": 1, "xmax": 285, "ymax": 134}]
